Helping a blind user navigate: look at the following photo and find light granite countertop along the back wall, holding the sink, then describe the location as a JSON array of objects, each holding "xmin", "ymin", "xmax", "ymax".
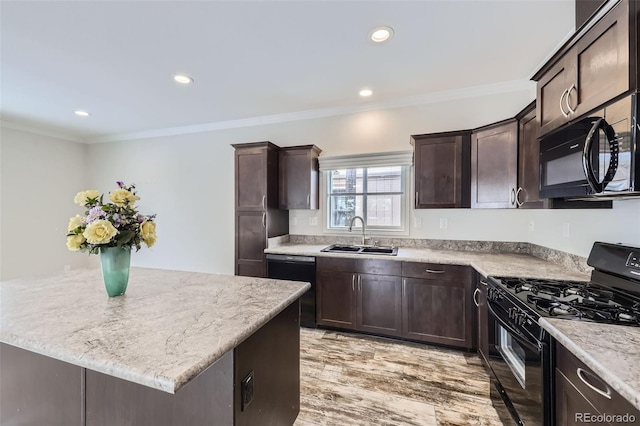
[{"xmin": 265, "ymin": 244, "xmax": 589, "ymax": 281}]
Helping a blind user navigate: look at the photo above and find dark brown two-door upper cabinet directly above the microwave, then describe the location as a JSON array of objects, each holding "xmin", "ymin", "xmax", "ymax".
[{"xmin": 533, "ymin": 0, "xmax": 639, "ymax": 135}]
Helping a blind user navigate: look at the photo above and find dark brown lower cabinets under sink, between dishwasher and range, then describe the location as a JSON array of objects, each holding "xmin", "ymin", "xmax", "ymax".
[{"xmin": 316, "ymin": 257, "xmax": 476, "ymax": 349}]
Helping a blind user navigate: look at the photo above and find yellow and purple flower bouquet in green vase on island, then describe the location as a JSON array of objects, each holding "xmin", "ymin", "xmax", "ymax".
[{"xmin": 67, "ymin": 182, "xmax": 157, "ymax": 296}]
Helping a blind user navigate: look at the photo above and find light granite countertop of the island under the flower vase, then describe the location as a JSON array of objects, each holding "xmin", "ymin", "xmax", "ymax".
[{"xmin": 0, "ymin": 268, "xmax": 310, "ymax": 393}]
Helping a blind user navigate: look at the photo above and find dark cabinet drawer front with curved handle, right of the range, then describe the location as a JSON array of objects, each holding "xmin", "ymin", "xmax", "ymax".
[{"xmin": 556, "ymin": 343, "xmax": 640, "ymax": 417}]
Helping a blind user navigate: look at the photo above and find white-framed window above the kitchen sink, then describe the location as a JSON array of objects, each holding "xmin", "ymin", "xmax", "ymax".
[{"xmin": 326, "ymin": 166, "xmax": 406, "ymax": 231}]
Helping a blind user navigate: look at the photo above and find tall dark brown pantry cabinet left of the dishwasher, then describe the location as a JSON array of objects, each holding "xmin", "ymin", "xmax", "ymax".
[{"xmin": 232, "ymin": 142, "xmax": 289, "ymax": 277}]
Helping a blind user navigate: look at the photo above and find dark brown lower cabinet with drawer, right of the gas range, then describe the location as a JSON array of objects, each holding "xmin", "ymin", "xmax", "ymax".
[{"xmin": 554, "ymin": 342, "xmax": 640, "ymax": 426}]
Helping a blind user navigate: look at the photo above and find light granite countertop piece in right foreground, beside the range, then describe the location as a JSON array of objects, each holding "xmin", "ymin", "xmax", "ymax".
[{"xmin": 539, "ymin": 318, "xmax": 640, "ymax": 410}]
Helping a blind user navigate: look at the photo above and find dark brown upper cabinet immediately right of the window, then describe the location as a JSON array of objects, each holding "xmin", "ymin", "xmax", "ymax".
[{"xmin": 411, "ymin": 130, "xmax": 471, "ymax": 209}]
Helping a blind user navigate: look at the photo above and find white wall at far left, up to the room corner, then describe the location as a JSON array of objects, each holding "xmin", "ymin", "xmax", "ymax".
[{"xmin": 0, "ymin": 127, "xmax": 87, "ymax": 279}]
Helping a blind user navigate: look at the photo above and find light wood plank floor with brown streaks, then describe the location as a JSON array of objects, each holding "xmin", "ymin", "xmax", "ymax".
[{"xmin": 295, "ymin": 328, "xmax": 502, "ymax": 426}]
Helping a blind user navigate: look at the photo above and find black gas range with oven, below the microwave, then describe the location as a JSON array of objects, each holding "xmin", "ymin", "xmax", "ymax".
[{"xmin": 483, "ymin": 242, "xmax": 640, "ymax": 426}]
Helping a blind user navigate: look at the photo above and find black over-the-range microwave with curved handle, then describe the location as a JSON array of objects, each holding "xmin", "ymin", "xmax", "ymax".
[{"xmin": 540, "ymin": 94, "xmax": 640, "ymax": 200}]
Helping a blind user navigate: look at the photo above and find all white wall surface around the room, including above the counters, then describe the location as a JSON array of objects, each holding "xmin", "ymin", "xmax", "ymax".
[{"xmin": 5, "ymin": 87, "xmax": 640, "ymax": 278}]
